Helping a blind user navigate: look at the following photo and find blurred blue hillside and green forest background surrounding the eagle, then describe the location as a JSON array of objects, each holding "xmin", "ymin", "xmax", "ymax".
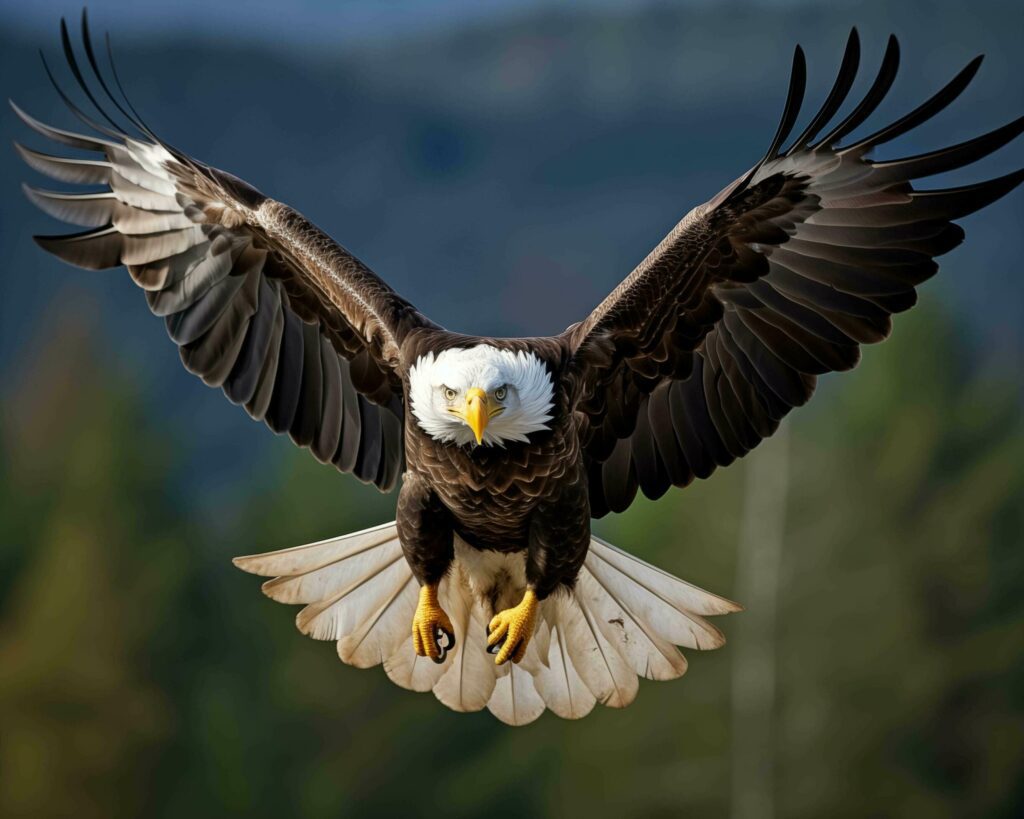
[{"xmin": 0, "ymin": 0, "xmax": 1024, "ymax": 819}]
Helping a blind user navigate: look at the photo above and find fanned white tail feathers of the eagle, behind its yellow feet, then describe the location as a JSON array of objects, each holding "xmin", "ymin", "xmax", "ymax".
[{"xmin": 234, "ymin": 522, "xmax": 741, "ymax": 725}]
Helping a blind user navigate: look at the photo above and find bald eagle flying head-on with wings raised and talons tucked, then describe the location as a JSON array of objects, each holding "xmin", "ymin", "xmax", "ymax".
[{"xmin": 14, "ymin": 15, "xmax": 1024, "ymax": 725}]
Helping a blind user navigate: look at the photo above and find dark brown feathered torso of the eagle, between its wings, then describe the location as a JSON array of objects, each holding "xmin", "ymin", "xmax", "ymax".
[{"xmin": 397, "ymin": 331, "xmax": 590, "ymax": 598}]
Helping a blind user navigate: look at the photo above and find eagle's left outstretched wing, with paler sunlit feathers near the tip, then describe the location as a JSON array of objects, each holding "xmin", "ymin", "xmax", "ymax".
[{"xmin": 11, "ymin": 13, "xmax": 432, "ymax": 490}]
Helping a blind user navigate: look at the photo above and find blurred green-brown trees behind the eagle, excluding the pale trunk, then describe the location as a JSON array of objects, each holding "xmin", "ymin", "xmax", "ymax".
[{"xmin": 0, "ymin": 309, "xmax": 1024, "ymax": 819}]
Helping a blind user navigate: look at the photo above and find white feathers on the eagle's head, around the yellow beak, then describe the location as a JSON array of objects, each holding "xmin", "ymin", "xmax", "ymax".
[{"xmin": 409, "ymin": 344, "xmax": 554, "ymax": 446}]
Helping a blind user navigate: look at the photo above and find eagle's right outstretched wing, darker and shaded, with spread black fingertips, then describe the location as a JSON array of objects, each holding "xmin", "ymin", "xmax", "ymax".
[{"xmin": 565, "ymin": 31, "xmax": 1024, "ymax": 517}]
